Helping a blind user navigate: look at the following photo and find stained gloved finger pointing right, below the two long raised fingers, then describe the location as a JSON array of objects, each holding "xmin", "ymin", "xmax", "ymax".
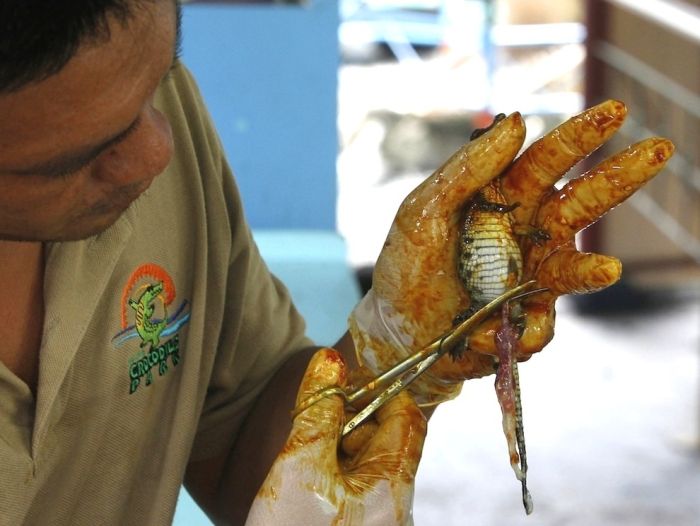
[{"xmin": 537, "ymin": 246, "xmax": 622, "ymax": 296}]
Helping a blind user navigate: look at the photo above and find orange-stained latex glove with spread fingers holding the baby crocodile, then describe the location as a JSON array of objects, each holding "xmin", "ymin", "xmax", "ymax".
[{"xmin": 349, "ymin": 101, "xmax": 673, "ymax": 405}]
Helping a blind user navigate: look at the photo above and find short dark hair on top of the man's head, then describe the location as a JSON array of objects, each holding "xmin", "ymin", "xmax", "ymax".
[{"xmin": 0, "ymin": 0, "xmax": 154, "ymax": 93}]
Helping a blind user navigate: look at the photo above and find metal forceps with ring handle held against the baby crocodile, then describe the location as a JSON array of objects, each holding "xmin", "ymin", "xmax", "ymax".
[{"xmin": 292, "ymin": 280, "xmax": 547, "ymax": 436}]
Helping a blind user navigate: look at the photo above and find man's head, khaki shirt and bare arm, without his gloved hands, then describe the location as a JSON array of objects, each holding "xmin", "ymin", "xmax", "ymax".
[{"xmin": 0, "ymin": 0, "xmax": 422, "ymax": 524}]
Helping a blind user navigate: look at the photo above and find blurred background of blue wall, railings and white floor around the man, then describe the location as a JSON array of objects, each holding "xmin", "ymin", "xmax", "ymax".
[{"xmin": 175, "ymin": 0, "xmax": 700, "ymax": 526}]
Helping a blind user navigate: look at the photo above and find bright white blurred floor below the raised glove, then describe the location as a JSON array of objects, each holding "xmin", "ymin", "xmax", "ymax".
[{"xmin": 414, "ymin": 299, "xmax": 700, "ymax": 526}]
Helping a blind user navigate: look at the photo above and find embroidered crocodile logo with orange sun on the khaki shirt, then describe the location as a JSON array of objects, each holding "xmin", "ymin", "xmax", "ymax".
[{"xmin": 112, "ymin": 263, "xmax": 190, "ymax": 394}]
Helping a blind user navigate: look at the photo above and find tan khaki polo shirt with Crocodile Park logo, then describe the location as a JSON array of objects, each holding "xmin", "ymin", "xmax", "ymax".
[{"xmin": 0, "ymin": 67, "xmax": 309, "ymax": 526}]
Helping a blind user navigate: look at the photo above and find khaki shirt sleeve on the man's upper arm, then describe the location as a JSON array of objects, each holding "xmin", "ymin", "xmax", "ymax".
[{"xmin": 191, "ymin": 160, "xmax": 313, "ymax": 460}]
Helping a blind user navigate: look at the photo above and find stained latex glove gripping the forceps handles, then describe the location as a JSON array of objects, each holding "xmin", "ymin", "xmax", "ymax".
[{"xmin": 246, "ymin": 349, "xmax": 426, "ymax": 526}]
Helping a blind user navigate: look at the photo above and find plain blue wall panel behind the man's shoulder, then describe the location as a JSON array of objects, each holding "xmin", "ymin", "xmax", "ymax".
[{"xmin": 183, "ymin": 0, "xmax": 339, "ymax": 230}]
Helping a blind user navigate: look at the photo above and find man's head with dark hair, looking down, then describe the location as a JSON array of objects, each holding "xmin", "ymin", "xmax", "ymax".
[{"xmin": 0, "ymin": 0, "xmax": 179, "ymax": 241}]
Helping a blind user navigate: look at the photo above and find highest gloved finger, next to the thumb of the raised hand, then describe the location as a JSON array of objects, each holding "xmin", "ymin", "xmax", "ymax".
[{"xmin": 501, "ymin": 100, "xmax": 627, "ymax": 225}]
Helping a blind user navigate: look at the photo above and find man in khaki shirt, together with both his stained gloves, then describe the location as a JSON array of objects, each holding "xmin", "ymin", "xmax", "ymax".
[{"xmin": 0, "ymin": 0, "xmax": 671, "ymax": 525}]
